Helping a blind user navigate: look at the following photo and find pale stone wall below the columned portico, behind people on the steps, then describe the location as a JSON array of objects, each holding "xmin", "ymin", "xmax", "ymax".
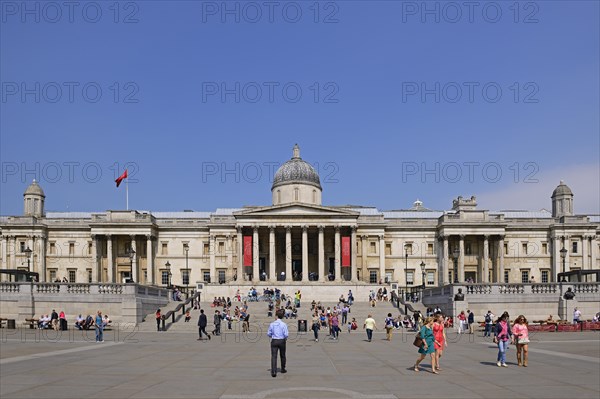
[{"xmin": 201, "ymin": 281, "xmax": 390, "ymax": 302}]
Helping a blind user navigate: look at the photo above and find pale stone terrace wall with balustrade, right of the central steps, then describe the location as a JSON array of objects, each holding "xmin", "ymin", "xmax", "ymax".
[{"xmin": 423, "ymin": 283, "xmax": 600, "ymax": 321}]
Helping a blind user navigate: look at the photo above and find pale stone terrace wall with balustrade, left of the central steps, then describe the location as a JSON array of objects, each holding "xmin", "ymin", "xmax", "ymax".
[{"xmin": 0, "ymin": 283, "xmax": 169, "ymax": 325}]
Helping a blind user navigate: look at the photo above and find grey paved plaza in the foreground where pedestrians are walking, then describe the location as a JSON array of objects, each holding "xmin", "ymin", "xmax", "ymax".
[{"xmin": 0, "ymin": 305, "xmax": 600, "ymax": 399}]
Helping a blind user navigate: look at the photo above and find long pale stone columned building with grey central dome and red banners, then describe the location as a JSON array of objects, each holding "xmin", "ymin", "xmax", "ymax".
[{"xmin": 0, "ymin": 146, "xmax": 600, "ymax": 286}]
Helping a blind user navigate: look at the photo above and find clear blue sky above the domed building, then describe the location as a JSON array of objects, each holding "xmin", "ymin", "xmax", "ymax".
[{"xmin": 0, "ymin": 1, "xmax": 600, "ymax": 215}]
